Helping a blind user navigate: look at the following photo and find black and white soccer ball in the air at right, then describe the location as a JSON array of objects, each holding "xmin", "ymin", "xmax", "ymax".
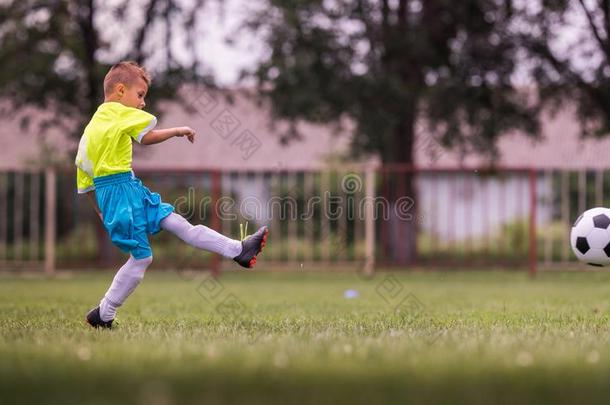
[{"xmin": 570, "ymin": 207, "xmax": 610, "ymax": 266}]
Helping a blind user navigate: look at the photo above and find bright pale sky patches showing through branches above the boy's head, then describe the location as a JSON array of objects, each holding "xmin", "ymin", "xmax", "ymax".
[{"xmin": 95, "ymin": 0, "xmax": 264, "ymax": 85}]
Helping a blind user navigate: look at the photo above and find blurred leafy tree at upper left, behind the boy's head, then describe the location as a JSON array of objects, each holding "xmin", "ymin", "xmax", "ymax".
[{"xmin": 0, "ymin": 0, "xmax": 210, "ymax": 264}]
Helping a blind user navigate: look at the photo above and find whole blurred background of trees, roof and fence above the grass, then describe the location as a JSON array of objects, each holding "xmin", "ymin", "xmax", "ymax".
[{"xmin": 0, "ymin": 0, "xmax": 610, "ymax": 273}]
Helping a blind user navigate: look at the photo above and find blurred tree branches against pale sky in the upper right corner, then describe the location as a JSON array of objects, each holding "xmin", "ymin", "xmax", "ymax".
[{"xmin": 514, "ymin": 0, "xmax": 610, "ymax": 137}]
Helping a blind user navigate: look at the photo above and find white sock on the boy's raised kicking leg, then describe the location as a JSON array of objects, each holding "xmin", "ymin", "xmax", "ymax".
[{"xmin": 161, "ymin": 212, "xmax": 242, "ymax": 259}]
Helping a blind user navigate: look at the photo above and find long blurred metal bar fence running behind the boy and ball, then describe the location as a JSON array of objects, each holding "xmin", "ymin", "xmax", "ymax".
[{"xmin": 0, "ymin": 165, "xmax": 576, "ymax": 272}]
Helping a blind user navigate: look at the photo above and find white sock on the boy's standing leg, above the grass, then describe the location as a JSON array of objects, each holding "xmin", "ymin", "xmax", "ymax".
[{"xmin": 100, "ymin": 256, "xmax": 152, "ymax": 322}]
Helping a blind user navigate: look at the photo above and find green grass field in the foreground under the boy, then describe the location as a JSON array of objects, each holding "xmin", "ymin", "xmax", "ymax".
[{"xmin": 0, "ymin": 266, "xmax": 610, "ymax": 404}]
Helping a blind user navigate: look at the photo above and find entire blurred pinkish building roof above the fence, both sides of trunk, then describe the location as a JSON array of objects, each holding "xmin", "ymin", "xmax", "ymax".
[{"xmin": 0, "ymin": 90, "xmax": 610, "ymax": 170}]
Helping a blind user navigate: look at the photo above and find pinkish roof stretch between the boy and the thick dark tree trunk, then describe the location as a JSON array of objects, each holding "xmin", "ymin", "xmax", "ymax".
[{"xmin": 134, "ymin": 90, "xmax": 349, "ymax": 170}]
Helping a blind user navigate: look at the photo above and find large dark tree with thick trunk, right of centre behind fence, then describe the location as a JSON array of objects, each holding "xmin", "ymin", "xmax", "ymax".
[{"xmin": 242, "ymin": 0, "xmax": 538, "ymax": 264}]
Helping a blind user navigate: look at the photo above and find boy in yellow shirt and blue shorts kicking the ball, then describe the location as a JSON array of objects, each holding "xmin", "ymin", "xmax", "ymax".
[{"xmin": 75, "ymin": 62, "xmax": 268, "ymax": 328}]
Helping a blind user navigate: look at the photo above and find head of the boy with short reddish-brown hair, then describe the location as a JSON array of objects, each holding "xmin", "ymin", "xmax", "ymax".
[{"xmin": 104, "ymin": 61, "xmax": 150, "ymax": 109}]
